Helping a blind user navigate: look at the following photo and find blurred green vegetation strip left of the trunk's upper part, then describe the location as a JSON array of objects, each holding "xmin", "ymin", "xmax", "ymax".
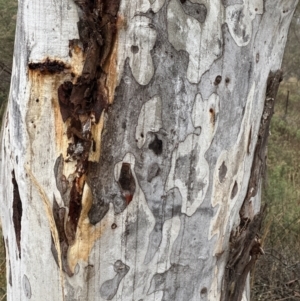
[{"xmin": 0, "ymin": 0, "xmax": 18, "ymax": 123}]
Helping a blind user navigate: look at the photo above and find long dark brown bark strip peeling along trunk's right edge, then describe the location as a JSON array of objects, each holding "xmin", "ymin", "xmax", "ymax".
[{"xmin": 221, "ymin": 70, "xmax": 282, "ymax": 301}]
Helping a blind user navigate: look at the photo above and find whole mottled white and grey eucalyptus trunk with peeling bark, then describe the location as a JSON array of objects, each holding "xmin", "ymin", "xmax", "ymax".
[{"xmin": 0, "ymin": 0, "xmax": 297, "ymax": 301}]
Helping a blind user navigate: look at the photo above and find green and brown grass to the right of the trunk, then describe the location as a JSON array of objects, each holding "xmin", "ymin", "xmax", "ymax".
[{"xmin": 251, "ymin": 80, "xmax": 300, "ymax": 301}]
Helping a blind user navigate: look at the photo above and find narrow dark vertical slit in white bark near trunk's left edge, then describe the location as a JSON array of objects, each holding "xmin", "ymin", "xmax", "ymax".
[{"xmin": 11, "ymin": 170, "xmax": 23, "ymax": 258}]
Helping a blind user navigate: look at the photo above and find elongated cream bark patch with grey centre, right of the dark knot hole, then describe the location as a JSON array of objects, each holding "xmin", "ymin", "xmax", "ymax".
[{"xmin": 165, "ymin": 93, "xmax": 219, "ymax": 216}]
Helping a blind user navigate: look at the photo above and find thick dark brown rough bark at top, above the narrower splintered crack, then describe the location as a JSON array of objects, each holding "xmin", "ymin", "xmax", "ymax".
[{"xmin": 58, "ymin": 0, "xmax": 120, "ymax": 122}]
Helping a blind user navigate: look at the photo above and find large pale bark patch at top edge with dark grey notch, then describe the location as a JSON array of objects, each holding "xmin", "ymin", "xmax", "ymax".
[{"xmin": 167, "ymin": 0, "xmax": 224, "ymax": 83}]
